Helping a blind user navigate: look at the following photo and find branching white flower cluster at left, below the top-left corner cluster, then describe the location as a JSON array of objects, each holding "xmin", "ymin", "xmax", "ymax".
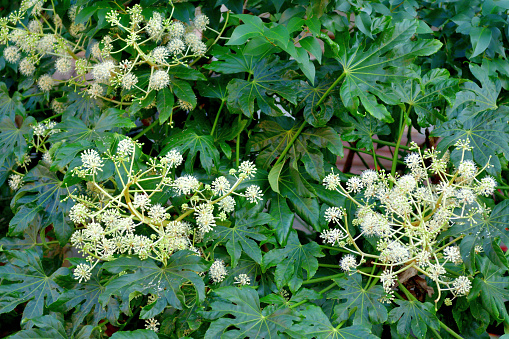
[{"xmin": 69, "ymin": 138, "xmax": 263, "ymax": 281}]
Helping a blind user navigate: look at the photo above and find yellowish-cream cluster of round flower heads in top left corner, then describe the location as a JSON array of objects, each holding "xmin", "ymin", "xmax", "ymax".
[{"xmin": 0, "ymin": 0, "xmax": 214, "ymax": 109}]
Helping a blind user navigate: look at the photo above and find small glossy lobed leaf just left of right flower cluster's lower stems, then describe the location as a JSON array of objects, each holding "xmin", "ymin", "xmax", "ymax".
[{"xmin": 262, "ymin": 232, "xmax": 324, "ymax": 292}]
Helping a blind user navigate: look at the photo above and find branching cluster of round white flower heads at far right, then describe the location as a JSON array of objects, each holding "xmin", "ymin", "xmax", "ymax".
[{"xmin": 321, "ymin": 139, "xmax": 497, "ymax": 302}]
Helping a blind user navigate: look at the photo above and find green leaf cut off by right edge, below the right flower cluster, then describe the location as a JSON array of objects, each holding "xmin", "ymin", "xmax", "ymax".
[{"xmin": 467, "ymin": 257, "xmax": 509, "ymax": 322}]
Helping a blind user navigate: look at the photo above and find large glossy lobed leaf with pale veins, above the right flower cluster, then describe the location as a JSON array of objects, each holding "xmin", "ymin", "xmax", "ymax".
[{"xmin": 319, "ymin": 20, "xmax": 442, "ymax": 122}]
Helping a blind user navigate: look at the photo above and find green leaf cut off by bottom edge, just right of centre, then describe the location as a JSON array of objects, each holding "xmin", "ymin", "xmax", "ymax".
[{"xmin": 292, "ymin": 305, "xmax": 377, "ymax": 339}]
